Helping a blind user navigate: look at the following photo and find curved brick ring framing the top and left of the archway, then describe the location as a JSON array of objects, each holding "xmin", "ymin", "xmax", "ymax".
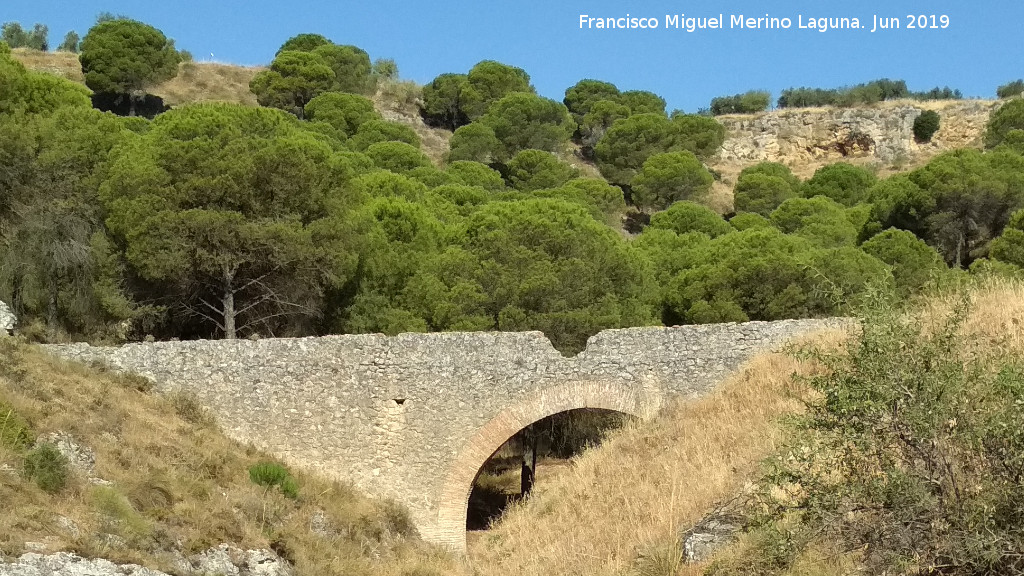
[{"xmin": 421, "ymin": 381, "xmax": 663, "ymax": 552}]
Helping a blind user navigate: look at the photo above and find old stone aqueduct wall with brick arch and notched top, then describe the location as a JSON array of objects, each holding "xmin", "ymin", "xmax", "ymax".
[{"xmin": 49, "ymin": 320, "xmax": 834, "ymax": 549}]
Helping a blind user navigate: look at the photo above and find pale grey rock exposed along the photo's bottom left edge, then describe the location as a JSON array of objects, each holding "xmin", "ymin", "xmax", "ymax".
[{"xmin": 0, "ymin": 544, "xmax": 294, "ymax": 576}]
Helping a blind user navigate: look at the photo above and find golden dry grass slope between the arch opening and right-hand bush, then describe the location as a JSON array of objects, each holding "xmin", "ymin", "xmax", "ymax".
[{"xmin": 470, "ymin": 333, "xmax": 841, "ymax": 576}]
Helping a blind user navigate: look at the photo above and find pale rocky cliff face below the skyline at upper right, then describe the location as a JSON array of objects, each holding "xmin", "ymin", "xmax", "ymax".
[{"xmin": 716, "ymin": 100, "xmax": 999, "ymax": 177}]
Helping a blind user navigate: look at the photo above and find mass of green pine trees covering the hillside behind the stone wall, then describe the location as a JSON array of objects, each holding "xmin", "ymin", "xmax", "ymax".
[{"xmin": 0, "ymin": 31, "xmax": 1024, "ymax": 354}]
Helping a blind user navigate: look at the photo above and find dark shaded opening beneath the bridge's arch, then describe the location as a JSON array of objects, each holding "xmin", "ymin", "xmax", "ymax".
[{"xmin": 466, "ymin": 408, "xmax": 635, "ymax": 532}]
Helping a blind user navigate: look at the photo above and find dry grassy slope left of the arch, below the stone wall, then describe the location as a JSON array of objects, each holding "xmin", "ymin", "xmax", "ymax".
[{"xmin": 0, "ymin": 338, "xmax": 461, "ymax": 575}]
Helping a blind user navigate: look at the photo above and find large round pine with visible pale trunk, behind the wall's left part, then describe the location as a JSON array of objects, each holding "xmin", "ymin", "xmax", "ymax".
[{"xmin": 99, "ymin": 105, "xmax": 354, "ymax": 338}]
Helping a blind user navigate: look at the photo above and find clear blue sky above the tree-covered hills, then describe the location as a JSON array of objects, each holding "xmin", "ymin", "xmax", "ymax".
[{"xmin": 0, "ymin": 0, "xmax": 1024, "ymax": 112}]
